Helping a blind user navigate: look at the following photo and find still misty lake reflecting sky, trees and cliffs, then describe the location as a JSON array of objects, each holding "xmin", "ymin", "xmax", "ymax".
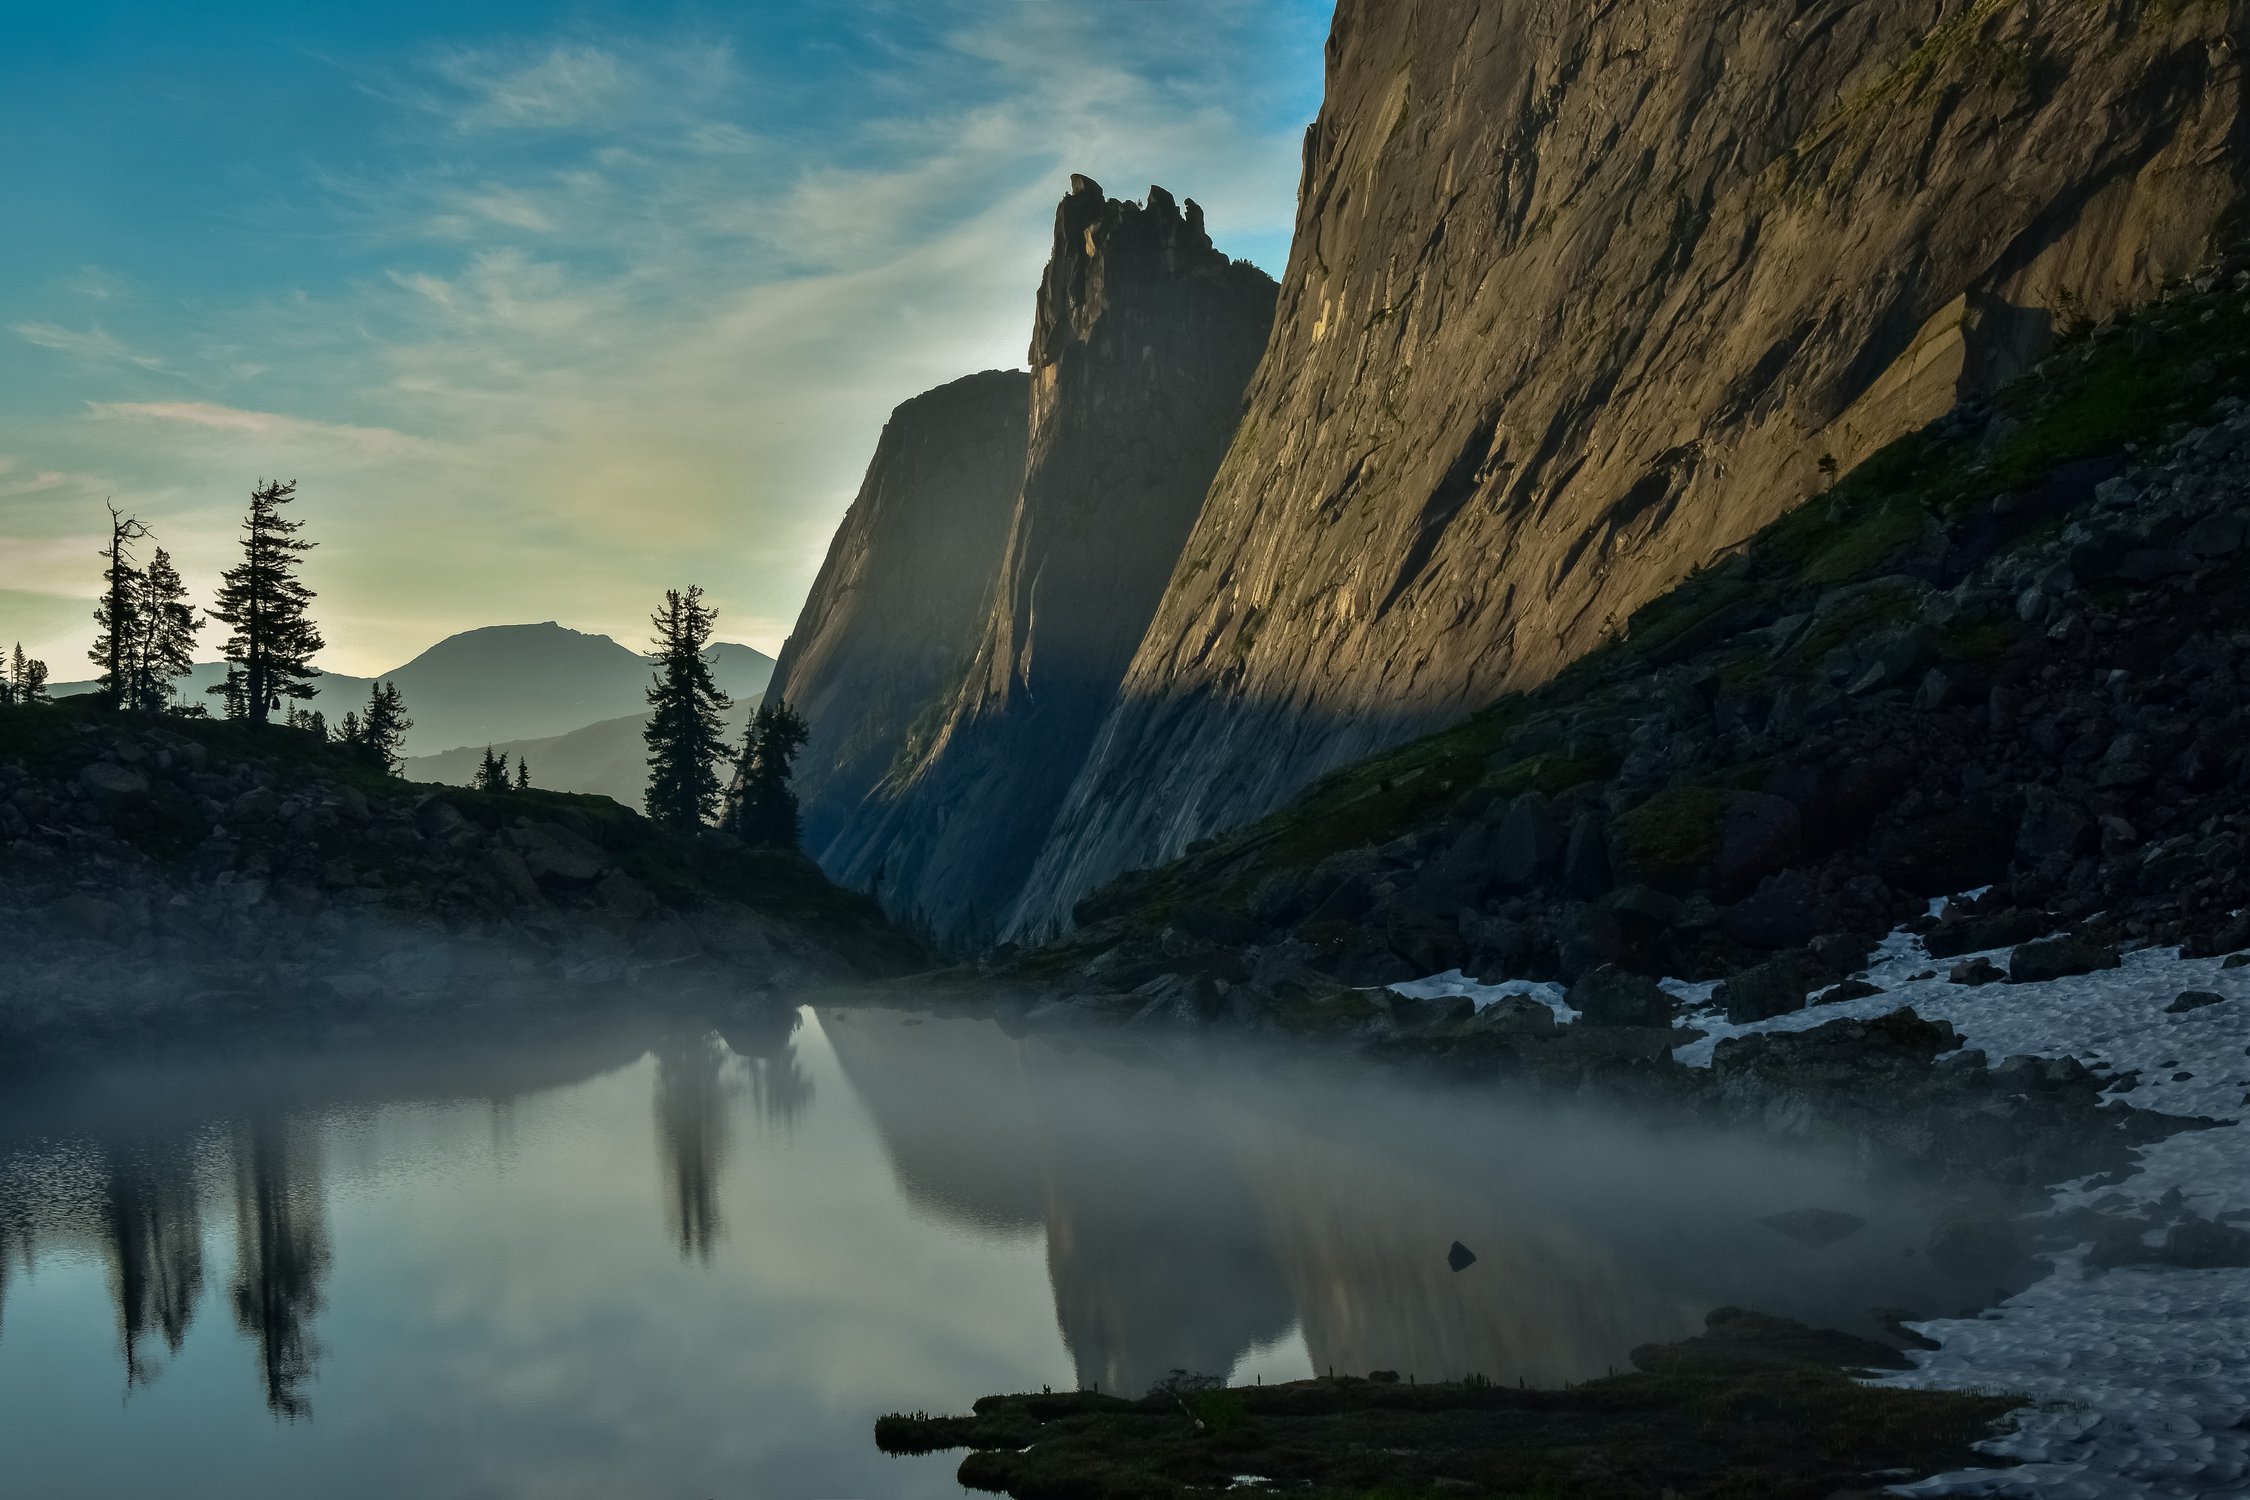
[{"xmin": 0, "ymin": 1007, "xmax": 1982, "ymax": 1500}]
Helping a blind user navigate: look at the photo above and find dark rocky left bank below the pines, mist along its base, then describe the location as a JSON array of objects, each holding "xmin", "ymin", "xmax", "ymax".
[{"xmin": 0, "ymin": 699, "xmax": 920, "ymax": 1055}]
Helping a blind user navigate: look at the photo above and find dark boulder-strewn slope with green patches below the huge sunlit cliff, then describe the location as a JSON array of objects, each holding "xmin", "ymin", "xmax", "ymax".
[{"xmin": 1017, "ymin": 254, "xmax": 2250, "ymax": 1020}]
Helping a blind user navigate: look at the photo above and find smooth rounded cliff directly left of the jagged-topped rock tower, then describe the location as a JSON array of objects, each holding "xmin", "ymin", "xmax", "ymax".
[{"xmin": 767, "ymin": 371, "xmax": 1031, "ymax": 859}]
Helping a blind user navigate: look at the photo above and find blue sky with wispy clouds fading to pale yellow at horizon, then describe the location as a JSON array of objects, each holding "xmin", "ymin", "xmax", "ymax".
[{"xmin": 0, "ymin": 0, "xmax": 1332, "ymax": 679}]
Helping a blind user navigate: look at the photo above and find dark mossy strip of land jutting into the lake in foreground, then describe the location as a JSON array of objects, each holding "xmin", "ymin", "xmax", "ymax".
[{"xmin": 875, "ymin": 1309, "xmax": 2023, "ymax": 1500}]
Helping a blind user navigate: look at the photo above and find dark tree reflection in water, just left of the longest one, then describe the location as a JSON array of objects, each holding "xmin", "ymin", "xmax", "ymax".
[{"xmin": 101, "ymin": 1147, "xmax": 203, "ymax": 1385}]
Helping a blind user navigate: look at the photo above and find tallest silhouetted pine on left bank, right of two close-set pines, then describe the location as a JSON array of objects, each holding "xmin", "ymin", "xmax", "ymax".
[{"xmin": 212, "ymin": 481, "xmax": 326, "ymax": 724}]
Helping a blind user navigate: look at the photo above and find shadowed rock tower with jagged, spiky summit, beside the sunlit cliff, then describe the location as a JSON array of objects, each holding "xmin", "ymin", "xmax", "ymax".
[{"xmin": 824, "ymin": 178, "xmax": 1276, "ymax": 933}]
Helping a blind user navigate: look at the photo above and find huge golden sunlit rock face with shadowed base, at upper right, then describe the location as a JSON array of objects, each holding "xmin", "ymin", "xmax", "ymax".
[{"xmin": 1008, "ymin": 0, "xmax": 2243, "ymax": 931}]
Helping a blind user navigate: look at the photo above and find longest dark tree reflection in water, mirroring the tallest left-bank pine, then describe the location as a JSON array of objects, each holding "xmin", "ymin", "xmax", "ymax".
[{"xmin": 234, "ymin": 1118, "xmax": 329, "ymax": 1419}]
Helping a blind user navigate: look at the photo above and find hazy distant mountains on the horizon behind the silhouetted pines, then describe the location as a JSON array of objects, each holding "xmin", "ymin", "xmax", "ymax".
[{"xmin": 54, "ymin": 621, "xmax": 774, "ymax": 756}]
